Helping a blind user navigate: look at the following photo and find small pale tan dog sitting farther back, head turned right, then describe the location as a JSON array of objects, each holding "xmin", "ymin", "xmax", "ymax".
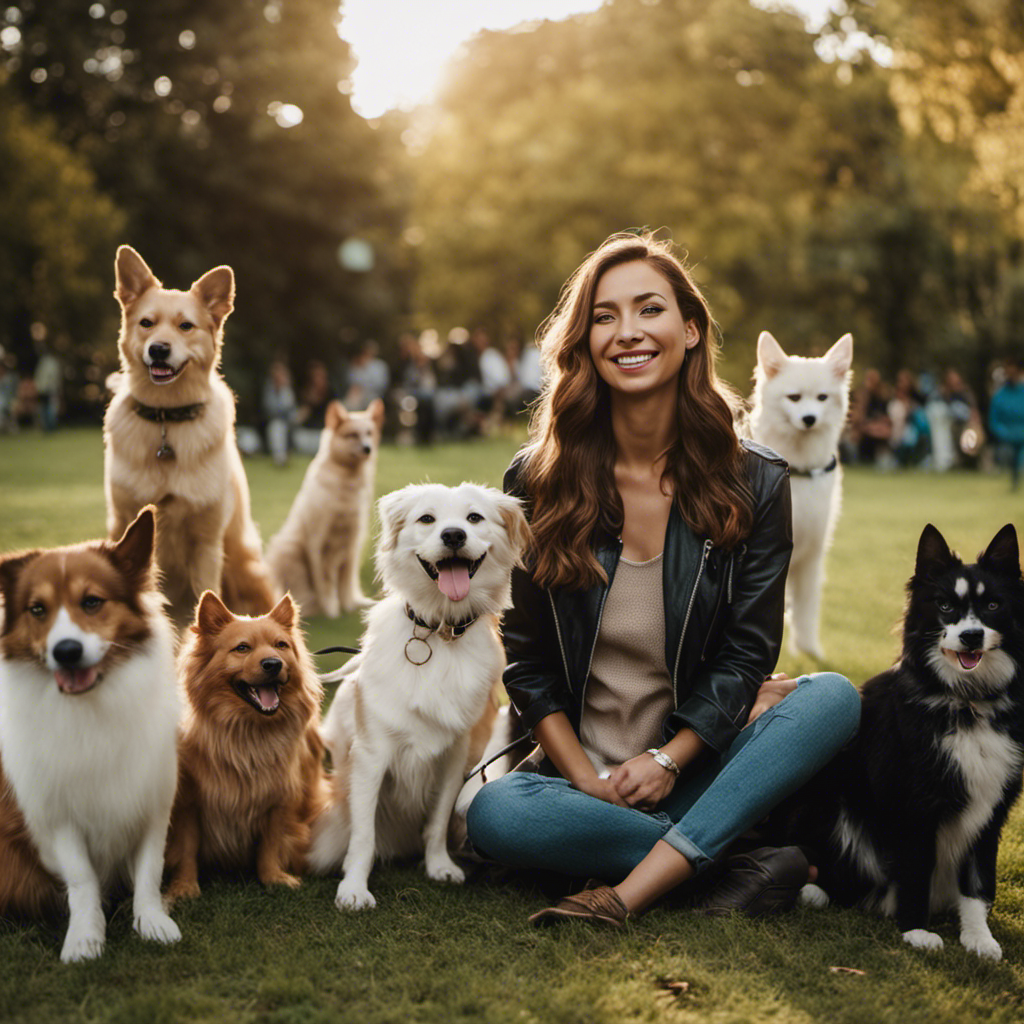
[{"xmin": 266, "ymin": 398, "xmax": 384, "ymax": 618}]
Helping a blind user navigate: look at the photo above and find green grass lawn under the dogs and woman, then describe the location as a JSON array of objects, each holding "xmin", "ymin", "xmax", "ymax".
[{"xmin": 0, "ymin": 430, "xmax": 1024, "ymax": 1024}]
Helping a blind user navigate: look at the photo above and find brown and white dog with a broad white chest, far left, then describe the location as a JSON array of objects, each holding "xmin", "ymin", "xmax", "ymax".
[{"xmin": 0, "ymin": 507, "xmax": 181, "ymax": 962}]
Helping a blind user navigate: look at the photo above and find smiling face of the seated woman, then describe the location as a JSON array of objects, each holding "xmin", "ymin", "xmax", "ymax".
[{"xmin": 590, "ymin": 260, "xmax": 700, "ymax": 396}]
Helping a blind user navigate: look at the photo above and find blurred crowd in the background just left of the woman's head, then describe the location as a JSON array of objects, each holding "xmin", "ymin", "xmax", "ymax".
[{"xmin": 252, "ymin": 328, "xmax": 541, "ymax": 464}]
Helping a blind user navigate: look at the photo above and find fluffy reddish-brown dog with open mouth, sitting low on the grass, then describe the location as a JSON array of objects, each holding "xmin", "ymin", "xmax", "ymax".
[{"xmin": 167, "ymin": 591, "xmax": 327, "ymax": 900}]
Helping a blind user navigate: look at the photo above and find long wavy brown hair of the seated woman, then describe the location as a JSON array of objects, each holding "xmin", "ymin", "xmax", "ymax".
[{"xmin": 523, "ymin": 232, "xmax": 753, "ymax": 588}]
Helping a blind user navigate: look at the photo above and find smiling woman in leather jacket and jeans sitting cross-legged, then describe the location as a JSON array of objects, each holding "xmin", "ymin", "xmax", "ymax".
[{"xmin": 467, "ymin": 231, "xmax": 860, "ymax": 926}]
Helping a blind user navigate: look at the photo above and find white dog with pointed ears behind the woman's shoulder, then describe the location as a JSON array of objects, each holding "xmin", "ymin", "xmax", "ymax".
[{"xmin": 751, "ymin": 331, "xmax": 853, "ymax": 658}]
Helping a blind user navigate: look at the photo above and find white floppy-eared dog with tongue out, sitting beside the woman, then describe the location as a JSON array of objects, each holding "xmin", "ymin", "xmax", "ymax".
[{"xmin": 309, "ymin": 483, "xmax": 529, "ymax": 910}]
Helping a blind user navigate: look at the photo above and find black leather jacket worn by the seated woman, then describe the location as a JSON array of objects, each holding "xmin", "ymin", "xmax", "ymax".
[{"xmin": 504, "ymin": 440, "xmax": 793, "ymax": 753}]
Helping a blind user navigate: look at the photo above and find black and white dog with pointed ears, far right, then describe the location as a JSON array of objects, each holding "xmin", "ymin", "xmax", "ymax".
[{"xmin": 786, "ymin": 524, "xmax": 1024, "ymax": 959}]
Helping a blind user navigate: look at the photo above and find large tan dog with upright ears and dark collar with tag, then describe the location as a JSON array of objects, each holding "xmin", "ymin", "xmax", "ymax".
[{"xmin": 103, "ymin": 246, "xmax": 274, "ymax": 623}]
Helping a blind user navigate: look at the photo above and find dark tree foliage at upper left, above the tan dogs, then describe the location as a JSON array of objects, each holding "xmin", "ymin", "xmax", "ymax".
[{"xmin": 8, "ymin": 0, "xmax": 408, "ymax": 411}]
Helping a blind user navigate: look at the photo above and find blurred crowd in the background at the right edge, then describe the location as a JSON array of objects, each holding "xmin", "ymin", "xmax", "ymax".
[{"xmin": 841, "ymin": 359, "xmax": 1024, "ymax": 488}]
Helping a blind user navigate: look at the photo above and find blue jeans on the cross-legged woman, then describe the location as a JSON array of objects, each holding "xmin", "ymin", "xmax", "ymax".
[{"xmin": 466, "ymin": 672, "xmax": 860, "ymax": 883}]
